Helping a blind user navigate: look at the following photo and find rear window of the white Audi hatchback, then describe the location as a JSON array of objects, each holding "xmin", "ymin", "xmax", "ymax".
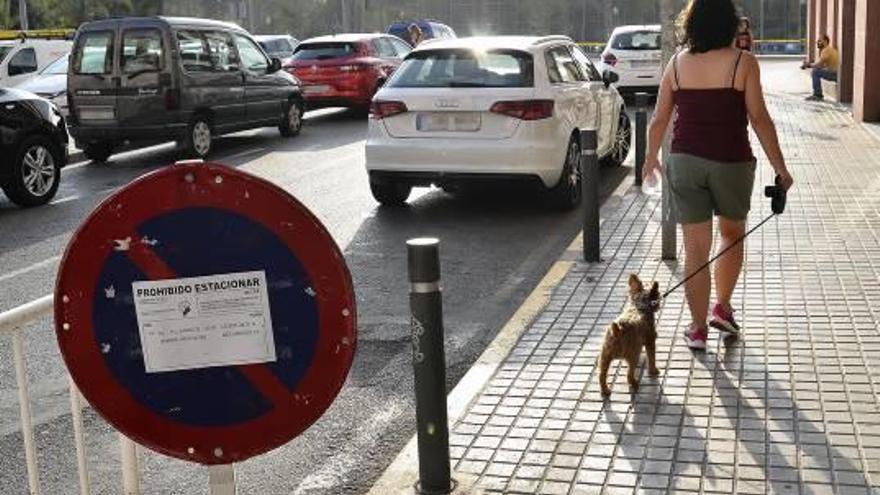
[{"xmin": 388, "ymin": 49, "xmax": 535, "ymax": 88}]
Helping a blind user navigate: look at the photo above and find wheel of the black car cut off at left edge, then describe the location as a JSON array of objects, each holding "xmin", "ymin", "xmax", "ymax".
[{"xmin": 3, "ymin": 136, "xmax": 61, "ymax": 206}]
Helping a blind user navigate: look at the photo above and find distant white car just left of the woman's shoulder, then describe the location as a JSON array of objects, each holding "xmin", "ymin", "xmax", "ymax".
[{"xmin": 599, "ymin": 25, "xmax": 662, "ymax": 94}]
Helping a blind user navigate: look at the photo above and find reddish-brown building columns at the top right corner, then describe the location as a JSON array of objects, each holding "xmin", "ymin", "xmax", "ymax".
[{"xmin": 807, "ymin": 0, "xmax": 880, "ymax": 122}]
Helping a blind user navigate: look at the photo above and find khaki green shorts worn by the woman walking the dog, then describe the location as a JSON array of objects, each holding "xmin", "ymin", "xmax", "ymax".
[{"xmin": 666, "ymin": 153, "xmax": 756, "ymax": 223}]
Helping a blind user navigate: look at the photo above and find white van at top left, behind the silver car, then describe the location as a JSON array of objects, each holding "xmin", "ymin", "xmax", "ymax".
[{"xmin": 0, "ymin": 38, "xmax": 71, "ymax": 88}]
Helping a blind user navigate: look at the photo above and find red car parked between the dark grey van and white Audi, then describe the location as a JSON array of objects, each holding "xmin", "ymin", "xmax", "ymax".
[{"xmin": 285, "ymin": 34, "xmax": 412, "ymax": 110}]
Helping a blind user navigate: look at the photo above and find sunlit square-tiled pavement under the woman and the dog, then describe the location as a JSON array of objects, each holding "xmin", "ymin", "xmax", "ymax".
[{"xmin": 450, "ymin": 64, "xmax": 880, "ymax": 494}]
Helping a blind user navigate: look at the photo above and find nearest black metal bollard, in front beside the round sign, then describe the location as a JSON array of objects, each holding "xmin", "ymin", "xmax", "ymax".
[{"xmin": 406, "ymin": 238, "xmax": 453, "ymax": 494}]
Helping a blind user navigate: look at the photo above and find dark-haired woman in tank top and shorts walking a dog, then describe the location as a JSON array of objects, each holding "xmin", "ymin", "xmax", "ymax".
[{"xmin": 644, "ymin": 0, "xmax": 793, "ymax": 349}]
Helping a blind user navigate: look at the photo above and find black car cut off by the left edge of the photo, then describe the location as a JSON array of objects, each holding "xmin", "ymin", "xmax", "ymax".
[{"xmin": 0, "ymin": 88, "xmax": 67, "ymax": 206}]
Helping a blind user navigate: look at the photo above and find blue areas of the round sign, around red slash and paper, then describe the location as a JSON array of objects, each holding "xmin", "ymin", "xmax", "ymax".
[{"xmin": 92, "ymin": 208, "xmax": 320, "ymax": 427}]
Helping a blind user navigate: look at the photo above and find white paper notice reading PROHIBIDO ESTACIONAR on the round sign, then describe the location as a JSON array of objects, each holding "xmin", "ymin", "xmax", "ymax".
[{"xmin": 132, "ymin": 271, "xmax": 275, "ymax": 373}]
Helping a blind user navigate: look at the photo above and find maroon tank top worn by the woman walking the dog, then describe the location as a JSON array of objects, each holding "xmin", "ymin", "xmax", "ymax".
[{"xmin": 672, "ymin": 51, "xmax": 755, "ymax": 162}]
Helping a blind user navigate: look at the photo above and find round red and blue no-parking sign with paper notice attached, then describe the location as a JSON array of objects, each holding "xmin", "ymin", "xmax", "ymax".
[{"xmin": 55, "ymin": 163, "xmax": 357, "ymax": 465}]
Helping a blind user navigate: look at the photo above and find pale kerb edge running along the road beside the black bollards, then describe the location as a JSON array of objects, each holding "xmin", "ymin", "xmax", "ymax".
[{"xmin": 368, "ymin": 175, "xmax": 635, "ymax": 495}]
